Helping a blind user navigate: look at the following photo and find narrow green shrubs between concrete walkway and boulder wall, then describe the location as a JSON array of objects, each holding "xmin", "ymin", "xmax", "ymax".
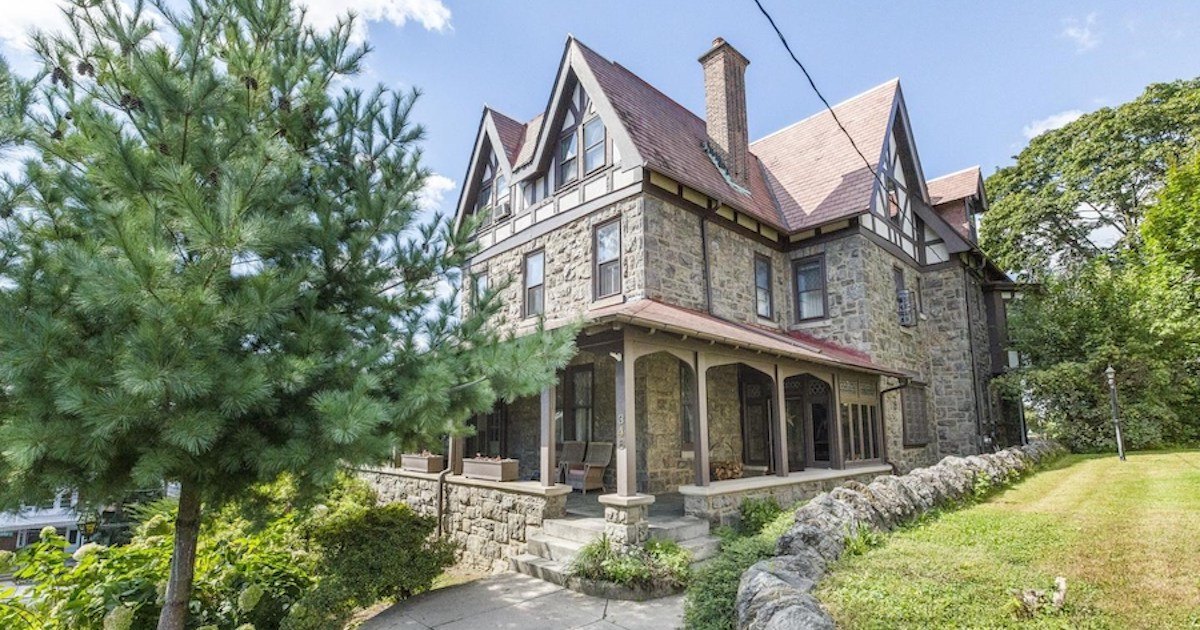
[{"xmin": 684, "ymin": 505, "xmax": 798, "ymax": 630}]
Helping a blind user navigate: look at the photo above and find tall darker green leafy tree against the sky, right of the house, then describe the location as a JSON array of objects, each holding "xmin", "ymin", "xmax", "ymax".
[{"xmin": 980, "ymin": 78, "xmax": 1200, "ymax": 277}]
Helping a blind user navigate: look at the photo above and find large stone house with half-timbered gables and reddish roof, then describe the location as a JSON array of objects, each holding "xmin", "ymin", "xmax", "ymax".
[{"xmin": 362, "ymin": 37, "xmax": 1024, "ymax": 568}]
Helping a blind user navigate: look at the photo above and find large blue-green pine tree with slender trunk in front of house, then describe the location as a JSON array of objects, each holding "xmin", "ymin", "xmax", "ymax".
[{"xmin": 0, "ymin": 0, "xmax": 572, "ymax": 629}]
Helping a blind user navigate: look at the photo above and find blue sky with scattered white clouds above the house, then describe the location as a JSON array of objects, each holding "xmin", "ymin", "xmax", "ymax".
[{"xmin": 0, "ymin": 0, "xmax": 1200, "ymax": 214}]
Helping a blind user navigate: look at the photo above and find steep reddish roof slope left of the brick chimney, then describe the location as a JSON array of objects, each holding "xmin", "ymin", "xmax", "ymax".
[{"xmin": 574, "ymin": 40, "xmax": 787, "ymax": 229}]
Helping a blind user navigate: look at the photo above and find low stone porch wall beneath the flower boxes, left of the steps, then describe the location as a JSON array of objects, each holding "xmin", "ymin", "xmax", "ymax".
[{"xmin": 359, "ymin": 468, "xmax": 570, "ymax": 572}]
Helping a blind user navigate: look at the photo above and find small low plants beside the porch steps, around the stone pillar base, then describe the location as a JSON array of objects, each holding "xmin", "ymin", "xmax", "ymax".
[{"xmin": 571, "ymin": 536, "xmax": 691, "ymax": 588}]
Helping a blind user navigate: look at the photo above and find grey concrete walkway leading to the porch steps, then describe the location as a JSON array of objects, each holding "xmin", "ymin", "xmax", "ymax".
[{"xmin": 361, "ymin": 574, "xmax": 683, "ymax": 630}]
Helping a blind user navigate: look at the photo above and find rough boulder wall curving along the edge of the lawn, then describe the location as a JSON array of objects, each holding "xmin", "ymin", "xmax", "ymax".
[{"xmin": 737, "ymin": 442, "xmax": 1066, "ymax": 630}]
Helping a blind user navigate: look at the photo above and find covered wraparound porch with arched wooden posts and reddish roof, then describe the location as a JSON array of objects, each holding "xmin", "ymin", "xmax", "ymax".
[{"xmin": 451, "ymin": 300, "xmax": 899, "ymax": 541}]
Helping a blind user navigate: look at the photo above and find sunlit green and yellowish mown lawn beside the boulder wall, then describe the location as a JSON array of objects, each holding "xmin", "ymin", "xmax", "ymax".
[{"xmin": 817, "ymin": 451, "xmax": 1200, "ymax": 628}]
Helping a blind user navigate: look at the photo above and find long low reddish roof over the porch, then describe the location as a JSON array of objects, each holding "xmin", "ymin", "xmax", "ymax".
[{"xmin": 587, "ymin": 299, "xmax": 905, "ymax": 377}]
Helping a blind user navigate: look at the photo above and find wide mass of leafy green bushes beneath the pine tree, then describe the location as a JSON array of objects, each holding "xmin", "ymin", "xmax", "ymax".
[{"xmin": 0, "ymin": 478, "xmax": 454, "ymax": 630}]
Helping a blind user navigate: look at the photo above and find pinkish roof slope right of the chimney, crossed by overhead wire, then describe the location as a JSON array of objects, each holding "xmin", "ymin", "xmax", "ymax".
[{"xmin": 750, "ymin": 79, "xmax": 900, "ymax": 230}]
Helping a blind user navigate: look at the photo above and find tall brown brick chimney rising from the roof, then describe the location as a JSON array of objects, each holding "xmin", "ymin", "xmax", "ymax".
[{"xmin": 700, "ymin": 37, "xmax": 750, "ymax": 187}]
